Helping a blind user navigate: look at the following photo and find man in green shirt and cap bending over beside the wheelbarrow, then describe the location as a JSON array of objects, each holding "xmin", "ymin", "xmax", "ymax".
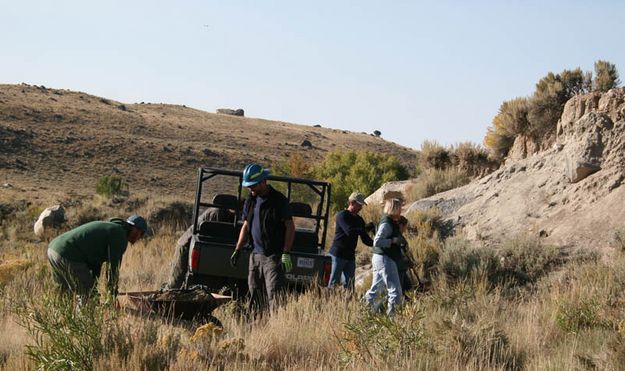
[{"xmin": 48, "ymin": 215, "xmax": 148, "ymax": 296}]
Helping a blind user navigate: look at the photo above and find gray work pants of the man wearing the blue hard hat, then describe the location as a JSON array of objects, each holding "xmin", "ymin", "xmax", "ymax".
[{"xmin": 247, "ymin": 253, "xmax": 286, "ymax": 312}]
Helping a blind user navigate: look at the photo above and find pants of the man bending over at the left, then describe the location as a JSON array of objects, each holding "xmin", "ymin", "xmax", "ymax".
[{"xmin": 48, "ymin": 249, "xmax": 95, "ymax": 296}]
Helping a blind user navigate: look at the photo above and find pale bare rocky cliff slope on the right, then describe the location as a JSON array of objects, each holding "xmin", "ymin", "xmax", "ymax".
[{"xmin": 407, "ymin": 88, "xmax": 625, "ymax": 248}]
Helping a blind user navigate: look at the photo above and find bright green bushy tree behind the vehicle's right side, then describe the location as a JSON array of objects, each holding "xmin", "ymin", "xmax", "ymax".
[{"xmin": 314, "ymin": 151, "xmax": 409, "ymax": 211}]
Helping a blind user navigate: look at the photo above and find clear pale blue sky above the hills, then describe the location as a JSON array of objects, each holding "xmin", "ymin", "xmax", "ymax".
[{"xmin": 0, "ymin": 0, "xmax": 625, "ymax": 149}]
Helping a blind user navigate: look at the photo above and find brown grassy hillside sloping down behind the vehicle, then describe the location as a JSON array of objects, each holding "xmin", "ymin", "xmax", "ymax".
[{"xmin": 0, "ymin": 84, "xmax": 415, "ymax": 198}]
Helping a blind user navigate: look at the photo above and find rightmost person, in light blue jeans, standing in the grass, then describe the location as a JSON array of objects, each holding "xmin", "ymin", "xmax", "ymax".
[{"xmin": 365, "ymin": 198, "xmax": 406, "ymax": 316}]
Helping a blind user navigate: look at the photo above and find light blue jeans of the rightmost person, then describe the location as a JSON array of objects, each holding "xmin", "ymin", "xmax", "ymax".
[{"xmin": 365, "ymin": 254, "xmax": 402, "ymax": 316}]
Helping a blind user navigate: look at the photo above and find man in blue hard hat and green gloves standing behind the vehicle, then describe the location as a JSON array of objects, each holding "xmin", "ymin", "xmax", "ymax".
[{"xmin": 230, "ymin": 164, "xmax": 295, "ymax": 312}]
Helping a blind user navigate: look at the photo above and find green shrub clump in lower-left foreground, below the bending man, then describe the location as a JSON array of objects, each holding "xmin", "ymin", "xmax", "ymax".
[{"xmin": 10, "ymin": 285, "xmax": 180, "ymax": 370}]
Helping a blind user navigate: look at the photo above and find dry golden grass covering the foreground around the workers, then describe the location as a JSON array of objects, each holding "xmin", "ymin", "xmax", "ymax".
[{"xmin": 0, "ymin": 193, "xmax": 625, "ymax": 370}]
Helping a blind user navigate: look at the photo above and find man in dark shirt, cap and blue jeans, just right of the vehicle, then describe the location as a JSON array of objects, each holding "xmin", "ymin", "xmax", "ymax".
[{"xmin": 328, "ymin": 192, "xmax": 373, "ymax": 290}]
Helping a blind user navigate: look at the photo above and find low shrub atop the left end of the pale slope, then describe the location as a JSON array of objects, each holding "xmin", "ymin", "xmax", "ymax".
[{"xmin": 408, "ymin": 168, "xmax": 472, "ymax": 201}]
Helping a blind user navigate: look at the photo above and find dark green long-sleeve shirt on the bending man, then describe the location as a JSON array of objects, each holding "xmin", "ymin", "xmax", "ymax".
[{"xmin": 49, "ymin": 218, "xmax": 131, "ymax": 294}]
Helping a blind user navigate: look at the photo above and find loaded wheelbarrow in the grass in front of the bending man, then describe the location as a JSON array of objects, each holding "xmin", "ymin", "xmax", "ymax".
[{"xmin": 117, "ymin": 288, "xmax": 232, "ymax": 325}]
